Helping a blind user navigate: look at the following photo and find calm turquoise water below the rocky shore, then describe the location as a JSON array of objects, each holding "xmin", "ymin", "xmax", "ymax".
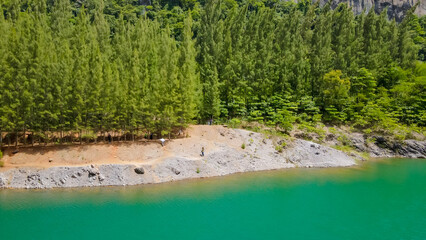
[{"xmin": 0, "ymin": 159, "xmax": 426, "ymax": 240}]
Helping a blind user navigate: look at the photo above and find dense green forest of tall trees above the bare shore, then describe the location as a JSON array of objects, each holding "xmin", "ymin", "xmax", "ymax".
[{"xmin": 0, "ymin": 0, "xmax": 426, "ymax": 144}]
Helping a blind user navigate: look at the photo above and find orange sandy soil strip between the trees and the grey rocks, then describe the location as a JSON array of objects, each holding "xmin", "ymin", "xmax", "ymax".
[{"xmin": 0, "ymin": 125, "xmax": 243, "ymax": 171}]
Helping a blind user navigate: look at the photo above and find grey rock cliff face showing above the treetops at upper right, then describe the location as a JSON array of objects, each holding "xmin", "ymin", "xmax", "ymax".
[{"xmin": 319, "ymin": 0, "xmax": 426, "ymax": 22}]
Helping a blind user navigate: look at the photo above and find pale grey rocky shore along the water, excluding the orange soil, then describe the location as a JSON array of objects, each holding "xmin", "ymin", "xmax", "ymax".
[{"xmin": 0, "ymin": 129, "xmax": 355, "ymax": 188}]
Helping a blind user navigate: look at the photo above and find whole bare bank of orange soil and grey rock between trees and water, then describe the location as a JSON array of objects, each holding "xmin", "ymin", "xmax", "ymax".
[{"xmin": 0, "ymin": 126, "xmax": 355, "ymax": 188}]
